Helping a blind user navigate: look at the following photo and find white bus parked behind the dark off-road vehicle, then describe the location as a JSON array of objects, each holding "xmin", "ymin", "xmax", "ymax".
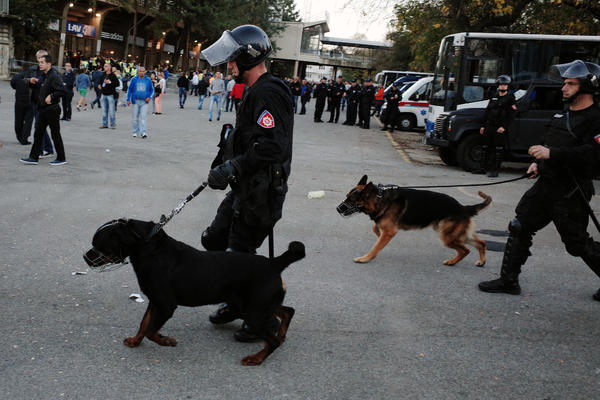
[{"xmin": 425, "ymin": 32, "xmax": 600, "ymax": 138}]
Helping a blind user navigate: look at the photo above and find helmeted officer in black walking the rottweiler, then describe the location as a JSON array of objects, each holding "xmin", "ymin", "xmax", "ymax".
[{"xmin": 202, "ymin": 25, "xmax": 294, "ymax": 342}]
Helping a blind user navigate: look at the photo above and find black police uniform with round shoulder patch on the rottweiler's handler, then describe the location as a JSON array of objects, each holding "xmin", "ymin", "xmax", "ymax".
[{"xmin": 202, "ymin": 73, "xmax": 294, "ymax": 253}]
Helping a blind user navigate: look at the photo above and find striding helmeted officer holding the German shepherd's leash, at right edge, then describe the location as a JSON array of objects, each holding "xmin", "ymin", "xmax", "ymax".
[{"xmin": 479, "ymin": 60, "xmax": 600, "ymax": 300}]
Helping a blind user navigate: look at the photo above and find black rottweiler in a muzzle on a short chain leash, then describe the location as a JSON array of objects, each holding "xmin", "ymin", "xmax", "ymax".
[{"xmin": 84, "ymin": 219, "xmax": 305, "ymax": 365}]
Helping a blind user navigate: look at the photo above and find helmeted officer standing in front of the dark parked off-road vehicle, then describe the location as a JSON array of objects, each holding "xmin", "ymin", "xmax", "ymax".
[{"xmin": 472, "ymin": 75, "xmax": 517, "ymax": 178}]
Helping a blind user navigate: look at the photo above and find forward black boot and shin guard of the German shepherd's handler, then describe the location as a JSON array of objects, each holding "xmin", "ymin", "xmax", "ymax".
[{"xmin": 479, "ymin": 218, "xmax": 531, "ymax": 295}]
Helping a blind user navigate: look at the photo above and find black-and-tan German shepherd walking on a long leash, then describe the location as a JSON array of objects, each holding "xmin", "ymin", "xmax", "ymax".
[{"xmin": 337, "ymin": 175, "xmax": 492, "ymax": 267}]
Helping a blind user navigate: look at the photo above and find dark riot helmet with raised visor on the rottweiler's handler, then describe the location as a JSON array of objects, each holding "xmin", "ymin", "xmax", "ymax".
[{"xmin": 202, "ymin": 25, "xmax": 273, "ymax": 74}]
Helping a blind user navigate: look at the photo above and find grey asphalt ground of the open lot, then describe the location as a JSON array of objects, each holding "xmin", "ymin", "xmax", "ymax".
[{"xmin": 0, "ymin": 82, "xmax": 600, "ymax": 400}]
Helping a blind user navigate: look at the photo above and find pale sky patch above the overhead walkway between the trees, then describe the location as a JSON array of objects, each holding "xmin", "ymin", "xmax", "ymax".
[{"xmin": 295, "ymin": 0, "xmax": 394, "ymax": 41}]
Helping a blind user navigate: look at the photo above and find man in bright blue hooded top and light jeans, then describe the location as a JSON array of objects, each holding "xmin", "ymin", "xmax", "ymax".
[{"xmin": 127, "ymin": 66, "xmax": 154, "ymax": 139}]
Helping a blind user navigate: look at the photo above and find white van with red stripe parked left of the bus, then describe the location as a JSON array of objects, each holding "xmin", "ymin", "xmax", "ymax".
[{"xmin": 381, "ymin": 76, "xmax": 433, "ymax": 131}]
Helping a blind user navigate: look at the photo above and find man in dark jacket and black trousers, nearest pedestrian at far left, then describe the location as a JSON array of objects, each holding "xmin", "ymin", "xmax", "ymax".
[{"xmin": 20, "ymin": 54, "xmax": 67, "ymax": 165}]
